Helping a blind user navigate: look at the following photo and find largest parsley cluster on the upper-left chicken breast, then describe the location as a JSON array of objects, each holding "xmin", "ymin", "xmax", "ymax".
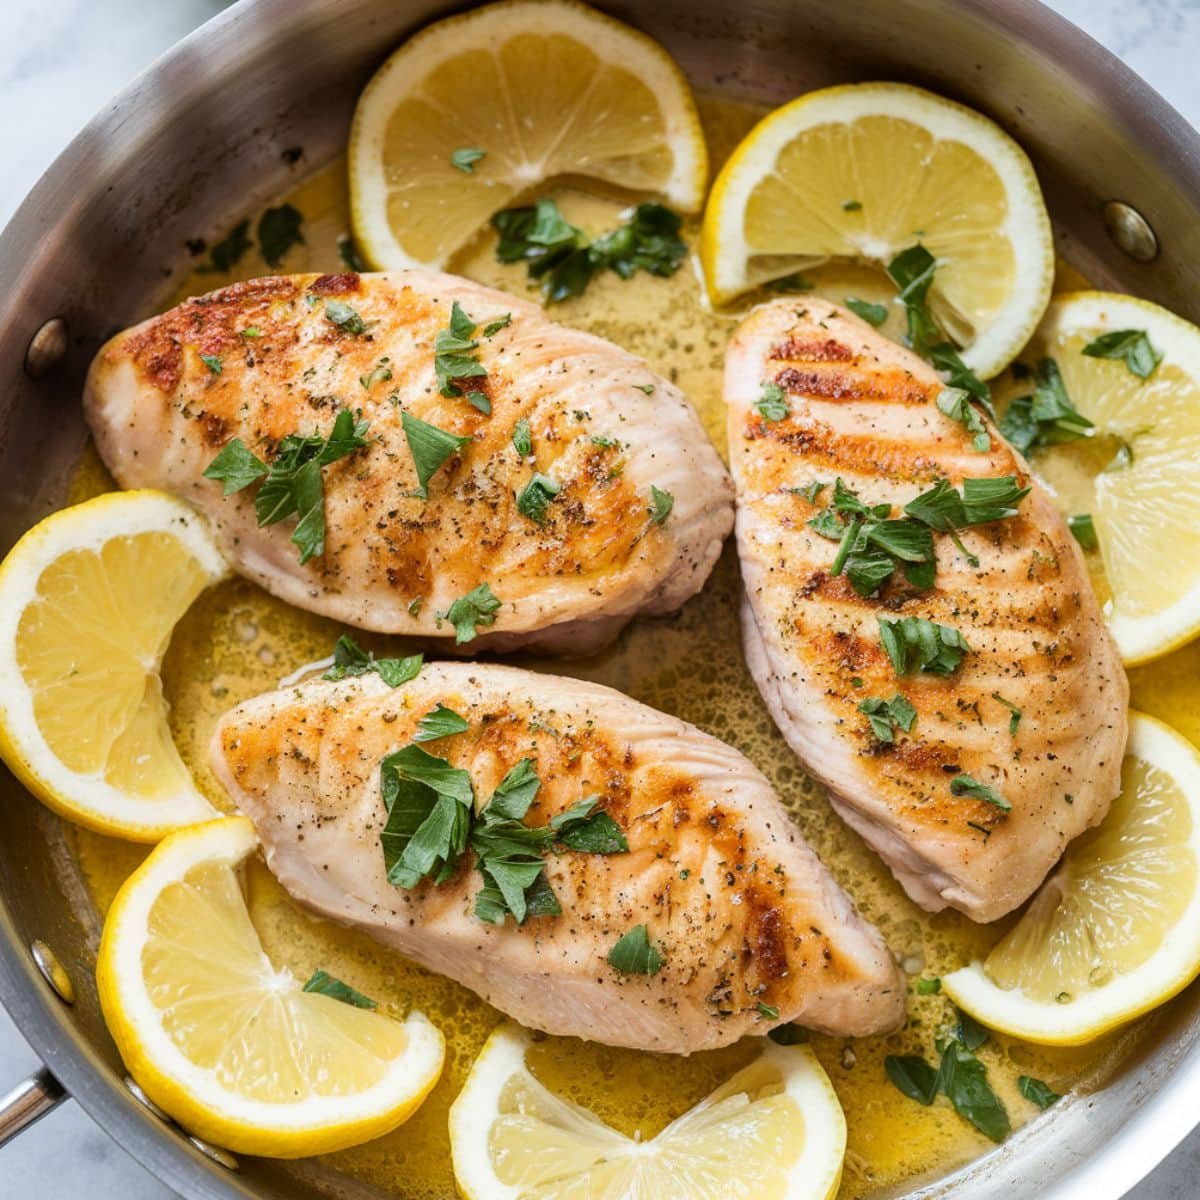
[{"xmin": 204, "ymin": 408, "xmax": 367, "ymax": 565}]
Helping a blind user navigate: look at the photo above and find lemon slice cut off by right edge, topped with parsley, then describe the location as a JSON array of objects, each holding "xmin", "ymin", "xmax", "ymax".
[{"xmin": 1030, "ymin": 292, "xmax": 1200, "ymax": 665}]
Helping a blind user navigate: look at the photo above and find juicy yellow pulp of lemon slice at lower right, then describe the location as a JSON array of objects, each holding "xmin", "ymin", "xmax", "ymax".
[{"xmin": 984, "ymin": 758, "xmax": 1196, "ymax": 1003}]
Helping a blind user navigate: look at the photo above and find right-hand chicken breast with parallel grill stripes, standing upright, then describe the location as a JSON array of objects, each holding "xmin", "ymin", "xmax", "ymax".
[{"xmin": 725, "ymin": 298, "xmax": 1128, "ymax": 922}]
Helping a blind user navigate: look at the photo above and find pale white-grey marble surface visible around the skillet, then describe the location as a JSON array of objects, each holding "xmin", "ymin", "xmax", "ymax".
[{"xmin": 0, "ymin": 0, "xmax": 1200, "ymax": 1200}]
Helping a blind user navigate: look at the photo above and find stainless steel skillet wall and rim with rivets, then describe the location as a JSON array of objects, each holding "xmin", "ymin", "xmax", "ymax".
[{"xmin": 0, "ymin": 0, "xmax": 1200, "ymax": 1200}]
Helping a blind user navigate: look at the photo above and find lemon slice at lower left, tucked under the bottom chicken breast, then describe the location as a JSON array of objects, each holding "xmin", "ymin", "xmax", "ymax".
[{"xmin": 96, "ymin": 817, "xmax": 445, "ymax": 1158}]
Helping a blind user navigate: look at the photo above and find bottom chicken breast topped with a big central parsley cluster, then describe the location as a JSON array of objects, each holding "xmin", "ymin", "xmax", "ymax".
[{"xmin": 211, "ymin": 664, "xmax": 905, "ymax": 1054}]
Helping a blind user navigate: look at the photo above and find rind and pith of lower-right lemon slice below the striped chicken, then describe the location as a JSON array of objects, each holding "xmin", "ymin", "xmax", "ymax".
[{"xmin": 942, "ymin": 712, "xmax": 1200, "ymax": 1046}]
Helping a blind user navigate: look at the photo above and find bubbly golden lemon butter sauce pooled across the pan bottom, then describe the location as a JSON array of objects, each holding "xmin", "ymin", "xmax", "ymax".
[{"xmin": 71, "ymin": 101, "xmax": 1185, "ymax": 1200}]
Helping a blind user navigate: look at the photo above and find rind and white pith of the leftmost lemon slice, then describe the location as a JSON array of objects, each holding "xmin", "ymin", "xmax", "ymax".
[{"xmin": 0, "ymin": 490, "xmax": 229, "ymax": 841}]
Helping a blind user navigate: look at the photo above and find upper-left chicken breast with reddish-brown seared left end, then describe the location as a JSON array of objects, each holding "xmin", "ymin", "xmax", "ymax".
[{"xmin": 84, "ymin": 270, "xmax": 733, "ymax": 653}]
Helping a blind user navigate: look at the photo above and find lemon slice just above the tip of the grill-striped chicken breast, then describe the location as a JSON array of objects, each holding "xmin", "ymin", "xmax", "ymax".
[{"xmin": 701, "ymin": 83, "xmax": 1054, "ymax": 378}]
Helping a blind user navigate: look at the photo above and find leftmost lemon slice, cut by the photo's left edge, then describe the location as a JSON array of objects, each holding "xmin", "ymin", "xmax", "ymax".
[{"xmin": 0, "ymin": 492, "xmax": 227, "ymax": 841}]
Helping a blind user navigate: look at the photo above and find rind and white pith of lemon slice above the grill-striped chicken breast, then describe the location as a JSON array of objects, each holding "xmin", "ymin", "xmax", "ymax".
[{"xmin": 701, "ymin": 82, "xmax": 1054, "ymax": 378}]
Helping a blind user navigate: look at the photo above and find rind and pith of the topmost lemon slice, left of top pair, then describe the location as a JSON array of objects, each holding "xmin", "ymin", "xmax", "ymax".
[{"xmin": 347, "ymin": 0, "xmax": 708, "ymax": 270}]
